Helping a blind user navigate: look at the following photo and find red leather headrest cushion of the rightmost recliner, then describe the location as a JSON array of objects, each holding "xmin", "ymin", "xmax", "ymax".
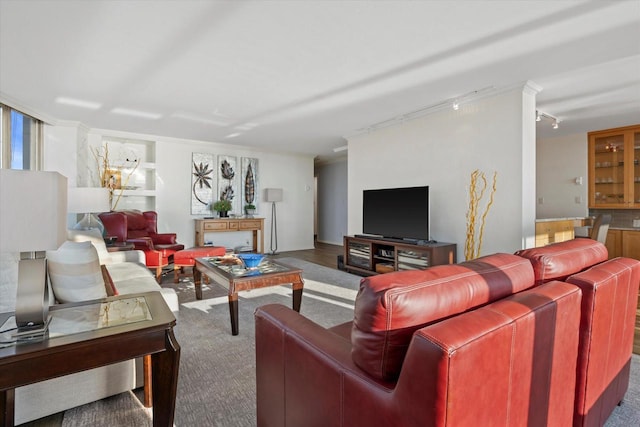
[{"xmin": 516, "ymin": 238, "xmax": 609, "ymax": 285}]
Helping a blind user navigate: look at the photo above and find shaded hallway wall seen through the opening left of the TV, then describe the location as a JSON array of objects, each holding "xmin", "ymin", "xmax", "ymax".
[{"xmin": 316, "ymin": 157, "xmax": 348, "ymax": 245}]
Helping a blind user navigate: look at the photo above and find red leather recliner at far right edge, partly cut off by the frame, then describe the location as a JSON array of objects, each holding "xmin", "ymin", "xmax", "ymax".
[{"xmin": 517, "ymin": 239, "xmax": 640, "ymax": 427}]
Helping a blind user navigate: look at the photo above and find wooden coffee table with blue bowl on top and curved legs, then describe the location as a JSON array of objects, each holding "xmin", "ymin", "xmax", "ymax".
[{"xmin": 193, "ymin": 257, "xmax": 304, "ymax": 335}]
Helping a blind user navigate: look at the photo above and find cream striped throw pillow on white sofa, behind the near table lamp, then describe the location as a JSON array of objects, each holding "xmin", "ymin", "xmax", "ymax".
[{"xmin": 47, "ymin": 240, "xmax": 107, "ymax": 303}]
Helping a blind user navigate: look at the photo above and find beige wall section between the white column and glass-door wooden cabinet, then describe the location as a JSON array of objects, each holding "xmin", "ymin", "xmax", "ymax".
[{"xmin": 536, "ymin": 133, "xmax": 589, "ymax": 218}]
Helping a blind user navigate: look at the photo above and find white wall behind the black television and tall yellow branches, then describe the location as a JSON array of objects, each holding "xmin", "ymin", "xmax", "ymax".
[{"xmin": 348, "ymin": 88, "xmax": 535, "ymax": 261}]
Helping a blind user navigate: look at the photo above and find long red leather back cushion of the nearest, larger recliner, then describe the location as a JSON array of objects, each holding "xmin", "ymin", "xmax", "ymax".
[{"xmin": 351, "ymin": 254, "xmax": 534, "ymax": 380}]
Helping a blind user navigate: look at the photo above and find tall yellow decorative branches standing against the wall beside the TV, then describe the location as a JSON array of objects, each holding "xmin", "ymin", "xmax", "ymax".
[{"xmin": 464, "ymin": 169, "xmax": 498, "ymax": 261}]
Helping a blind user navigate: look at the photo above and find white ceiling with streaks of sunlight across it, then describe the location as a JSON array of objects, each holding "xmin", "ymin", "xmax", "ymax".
[{"xmin": 0, "ymin": 0, "xmax": 640, "ymax": 161}]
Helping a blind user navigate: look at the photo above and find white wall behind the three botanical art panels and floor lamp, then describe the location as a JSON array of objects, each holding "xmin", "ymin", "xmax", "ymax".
[{"xmin": 45, "ymin": 124, "xmax": 313, "ymax": 252}]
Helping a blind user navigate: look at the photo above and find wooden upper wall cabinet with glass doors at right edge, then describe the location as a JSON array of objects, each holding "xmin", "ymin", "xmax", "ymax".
[{"xmin": 588, "ymin": 125, "xmax": 640, "ymax": 209}]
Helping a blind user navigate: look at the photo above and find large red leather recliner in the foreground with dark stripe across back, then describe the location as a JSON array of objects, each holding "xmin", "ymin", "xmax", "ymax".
[{"xmin": 255, "ymin": 254, "xmax": 580, "ymax": 427}]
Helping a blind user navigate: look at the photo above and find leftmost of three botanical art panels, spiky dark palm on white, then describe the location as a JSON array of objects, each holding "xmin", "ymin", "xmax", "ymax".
[{"xmin": 191, "ymin": 153, "xmax": 217, "ymax": 216}]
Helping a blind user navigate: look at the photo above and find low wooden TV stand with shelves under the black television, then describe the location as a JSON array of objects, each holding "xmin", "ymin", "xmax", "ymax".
[{"xmin": 344, "ymin": 236, "xmax": 456, "ymax": 275}]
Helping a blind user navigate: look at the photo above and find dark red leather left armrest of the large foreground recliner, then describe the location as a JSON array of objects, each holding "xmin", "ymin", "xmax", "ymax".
[{"xmin": 255, "ymin": 304, "xmax": 389, "ymax": 426}]
